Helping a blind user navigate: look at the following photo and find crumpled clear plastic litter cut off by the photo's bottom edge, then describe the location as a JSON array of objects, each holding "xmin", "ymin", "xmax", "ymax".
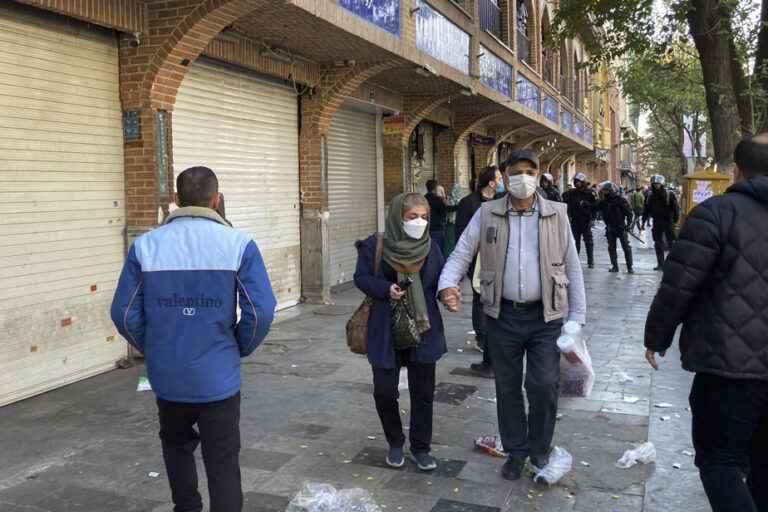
[{"xmin": 285, "ymin": 483, "xmax": 381, "ymax": 512}]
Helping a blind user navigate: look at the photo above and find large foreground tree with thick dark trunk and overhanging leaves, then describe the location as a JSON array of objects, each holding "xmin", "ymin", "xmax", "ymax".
[{"xmin": 553, "ymin": 0, "xmax": 768, "ymax": 165}]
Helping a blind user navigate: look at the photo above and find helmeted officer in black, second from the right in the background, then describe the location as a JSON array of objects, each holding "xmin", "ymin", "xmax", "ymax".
[{"xmin": 595, "ymin": 181, "xmax": 635, "ymax": 274}]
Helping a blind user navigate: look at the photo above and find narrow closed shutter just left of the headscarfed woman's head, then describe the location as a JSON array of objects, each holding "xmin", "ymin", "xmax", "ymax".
[{"xmin": 328, "ymin": 107, "xmax": 377, "ymax": 285}]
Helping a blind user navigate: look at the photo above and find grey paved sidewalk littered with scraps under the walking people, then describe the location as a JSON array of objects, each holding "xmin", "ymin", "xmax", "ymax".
[{"xmin": 0, "ymin": 228, "xmax": 709, "ymax": 512}]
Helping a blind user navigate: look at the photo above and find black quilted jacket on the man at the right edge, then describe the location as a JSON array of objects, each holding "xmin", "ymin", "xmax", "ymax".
[{"xmin": 645, "ymin": 176, "xmax": 768, "ymax": 380}]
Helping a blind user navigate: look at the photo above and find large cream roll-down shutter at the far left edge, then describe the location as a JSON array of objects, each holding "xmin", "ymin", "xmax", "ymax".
[{"xmin": 0, "ymin": 6, "xmax": 126, "ymax": 405}]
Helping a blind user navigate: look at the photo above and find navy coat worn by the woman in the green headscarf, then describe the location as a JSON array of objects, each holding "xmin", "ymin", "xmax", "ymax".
[{"xmin": 355, "ymin": 236, "xmax": 447, "ymax": 368}]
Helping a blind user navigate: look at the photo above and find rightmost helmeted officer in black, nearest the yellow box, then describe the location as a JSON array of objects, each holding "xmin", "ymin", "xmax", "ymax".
[{"xmin": 643, "ymin": 174, "xmax": 680, "ymax": 270}]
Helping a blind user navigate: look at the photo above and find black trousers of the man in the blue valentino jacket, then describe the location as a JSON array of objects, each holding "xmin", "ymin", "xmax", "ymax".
[{"xmin": 157, "ymin": 393, "xmax": 243, "ymax": 512}]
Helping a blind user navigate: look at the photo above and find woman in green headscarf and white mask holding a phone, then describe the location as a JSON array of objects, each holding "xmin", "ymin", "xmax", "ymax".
[{"xmin": 355, "ymin": 193, "xmax": 446, "ymax": 471}]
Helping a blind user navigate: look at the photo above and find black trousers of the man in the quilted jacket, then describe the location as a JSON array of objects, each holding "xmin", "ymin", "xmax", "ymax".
[{"xmin": 690, "ymin": 373, "xmax": 768, "ymax": 512}]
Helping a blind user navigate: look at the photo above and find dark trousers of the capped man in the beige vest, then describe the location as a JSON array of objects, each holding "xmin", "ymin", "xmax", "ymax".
[{"xmin": 488, "ymin": 301, "xmax": 563, "ymax": 460}]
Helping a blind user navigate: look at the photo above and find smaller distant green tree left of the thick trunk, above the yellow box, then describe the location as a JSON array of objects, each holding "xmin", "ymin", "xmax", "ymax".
[{"xmin": 618, "ymin": 43, "xmax": 709, "ymax": 178}]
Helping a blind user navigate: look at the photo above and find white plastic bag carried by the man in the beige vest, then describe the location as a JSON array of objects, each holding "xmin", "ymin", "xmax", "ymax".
[{"xmin": 557, "ymin": 322, "xmax": 595, "ymax": 397}]
